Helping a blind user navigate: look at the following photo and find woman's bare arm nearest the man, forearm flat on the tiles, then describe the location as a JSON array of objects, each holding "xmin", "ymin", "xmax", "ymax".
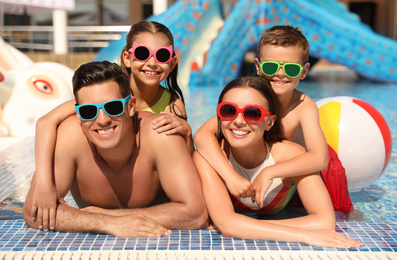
[{"xmin": 193, "ymin": 152, "xmax": 361, "ymax": 248}]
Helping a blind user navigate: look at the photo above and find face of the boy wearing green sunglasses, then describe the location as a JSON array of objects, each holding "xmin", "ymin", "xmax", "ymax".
[{"xmin": 255, "ymin": 45, "xmax": 310, "ymax": 95}]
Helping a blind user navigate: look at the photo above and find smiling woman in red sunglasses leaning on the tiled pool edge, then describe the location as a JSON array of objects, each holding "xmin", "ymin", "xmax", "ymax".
[{"xmin": 193, "ymin": 76, "xmax": 362, "ymax": 248}]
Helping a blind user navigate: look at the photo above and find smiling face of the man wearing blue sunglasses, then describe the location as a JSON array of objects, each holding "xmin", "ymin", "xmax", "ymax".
[{"xmin": 77, "ymin": 81, "xmax": 135, "ymax": 150}]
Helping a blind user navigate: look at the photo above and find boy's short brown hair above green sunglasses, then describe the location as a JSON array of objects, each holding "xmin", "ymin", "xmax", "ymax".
[{"xmin": 257, "ymin": 25, "xmax": 310, "ymax": 64}]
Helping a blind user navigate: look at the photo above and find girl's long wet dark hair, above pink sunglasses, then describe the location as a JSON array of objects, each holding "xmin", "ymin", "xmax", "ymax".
[{"xmin": 120, "ymin": 20, "xmax": 186, "ymax": 119}]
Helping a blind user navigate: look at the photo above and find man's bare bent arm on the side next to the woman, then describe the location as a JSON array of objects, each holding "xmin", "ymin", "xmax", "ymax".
[{"xmin": 94, "ymin": 117, "xmax": 208, "ymax": 229}]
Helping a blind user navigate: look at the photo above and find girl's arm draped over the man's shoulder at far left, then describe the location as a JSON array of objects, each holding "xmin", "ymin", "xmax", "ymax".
[{"xmin": 30, "ymin": 100, "xmax": 75, "ymax": 230}]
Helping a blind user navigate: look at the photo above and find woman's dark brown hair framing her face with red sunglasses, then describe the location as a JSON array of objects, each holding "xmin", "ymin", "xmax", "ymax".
[{"xmin": 217, "ymin": 75, "xmax": 285, "ymax": 143}]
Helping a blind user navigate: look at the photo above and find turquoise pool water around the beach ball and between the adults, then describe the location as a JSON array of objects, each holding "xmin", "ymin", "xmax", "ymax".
[{"xmin": 185, "ymin": 81, "xmax": 397, "ymax": 221}]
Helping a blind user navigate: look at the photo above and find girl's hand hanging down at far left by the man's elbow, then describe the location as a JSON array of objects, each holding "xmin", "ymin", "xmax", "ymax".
[{"xmin": 31, "ymin": 184, "xmax": 67, "ymax": 231}]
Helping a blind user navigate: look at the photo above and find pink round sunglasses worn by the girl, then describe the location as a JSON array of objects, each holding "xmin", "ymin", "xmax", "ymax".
[{"xmin": 128, "ymin": 42, "xmax": 172, "ymax": 63}]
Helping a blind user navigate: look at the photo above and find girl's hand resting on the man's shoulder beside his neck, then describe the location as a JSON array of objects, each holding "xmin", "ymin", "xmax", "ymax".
[{"xmin": 153, "ymin": 112, "xmax": 192, "ymax": 138}]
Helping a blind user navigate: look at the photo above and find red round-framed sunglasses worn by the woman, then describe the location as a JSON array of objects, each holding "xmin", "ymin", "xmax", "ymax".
[{"xmin": 216, "ymin": 102, "xmax": 273, "ymax": 124}]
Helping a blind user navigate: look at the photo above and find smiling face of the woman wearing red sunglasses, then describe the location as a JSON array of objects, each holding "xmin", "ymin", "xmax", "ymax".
[{"xmin": 221, "ymin": 87, "xmax": 276, "ymax": 148}]
